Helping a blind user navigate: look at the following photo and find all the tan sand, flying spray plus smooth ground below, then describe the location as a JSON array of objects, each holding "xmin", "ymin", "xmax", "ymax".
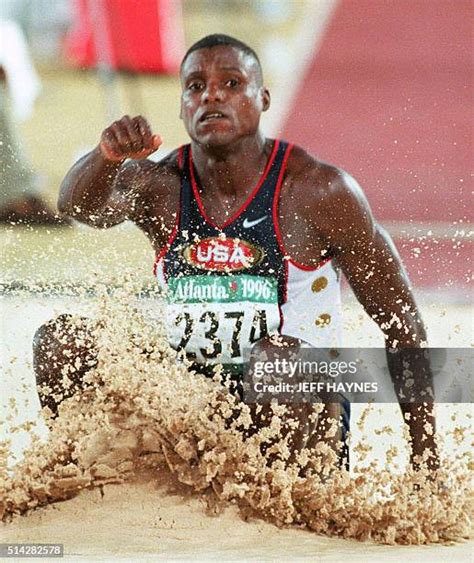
[{"xmin": 0, "ymin": 288, "xmax": 471, "ymax": 561}]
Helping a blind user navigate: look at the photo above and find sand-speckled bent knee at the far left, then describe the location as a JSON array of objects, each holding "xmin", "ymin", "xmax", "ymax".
[{"xmin": 33, "ymin": 315, "xmax": 97, "ymax": 414}]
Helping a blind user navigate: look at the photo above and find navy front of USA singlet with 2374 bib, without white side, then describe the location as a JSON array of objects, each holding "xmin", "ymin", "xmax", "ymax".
[{"xmin": 150, "ymin": 142, "xmax": 287, "ymax": 365}]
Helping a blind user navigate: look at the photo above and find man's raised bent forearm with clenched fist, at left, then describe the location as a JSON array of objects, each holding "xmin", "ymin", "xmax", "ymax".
[{"xmin": 58, "ymin": 116, "xmax": 162, "ymax": 227}]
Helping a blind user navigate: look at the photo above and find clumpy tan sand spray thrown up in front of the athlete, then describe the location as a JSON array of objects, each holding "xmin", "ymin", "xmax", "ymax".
[{"xmin": 0, "ymin": 286, "xmax": 472, "ymax": 544}]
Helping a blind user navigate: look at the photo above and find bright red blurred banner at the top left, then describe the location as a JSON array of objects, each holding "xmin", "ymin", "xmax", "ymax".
[{"xmin": 65, "ymin": 0, "xmax": 184, "ymax": 74}]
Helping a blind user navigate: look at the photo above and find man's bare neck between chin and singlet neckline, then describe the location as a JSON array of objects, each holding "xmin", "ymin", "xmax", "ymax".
[{"xmin": 191, "ymin": 132, "xmax": 268, "ymax": 199}]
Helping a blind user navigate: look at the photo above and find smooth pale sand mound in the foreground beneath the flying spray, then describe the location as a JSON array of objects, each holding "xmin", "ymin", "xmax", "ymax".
[{"xmin": 2, "ymin": 475, "xmax": 472, "ymax": 562}]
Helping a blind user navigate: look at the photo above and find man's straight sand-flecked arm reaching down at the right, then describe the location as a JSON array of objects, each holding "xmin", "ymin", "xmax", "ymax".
[{"xmin": 315, "ymin": 167, "xmax": 438, "ymax": 476}]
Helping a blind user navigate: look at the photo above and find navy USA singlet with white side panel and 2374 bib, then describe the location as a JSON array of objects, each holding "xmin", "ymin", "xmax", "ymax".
[{"xmin": 154, "ymin": 140, "xmax": 342, "ymax": 371}]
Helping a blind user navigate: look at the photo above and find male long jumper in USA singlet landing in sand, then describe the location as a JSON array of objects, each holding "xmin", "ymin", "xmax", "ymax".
[{"xmin": 35, "ymin": 35, "xmax": 437, "ymax": 474}]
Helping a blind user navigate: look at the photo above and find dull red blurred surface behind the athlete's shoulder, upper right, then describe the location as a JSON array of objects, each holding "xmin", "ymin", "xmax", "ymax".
[{"xmin": 284, "ymin": 0, "xmax": 474, "ymax": 222}]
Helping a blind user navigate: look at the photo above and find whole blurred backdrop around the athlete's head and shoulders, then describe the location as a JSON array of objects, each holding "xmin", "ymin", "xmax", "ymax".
[{"xmin": 0, "ymin": 0, "xmax": 474, "ymax": 304}]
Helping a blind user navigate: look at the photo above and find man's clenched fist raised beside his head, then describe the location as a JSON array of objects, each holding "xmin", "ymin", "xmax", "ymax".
[{"xmin": 99, "ymin": 115, "xmax": 162, "ymax": 162}]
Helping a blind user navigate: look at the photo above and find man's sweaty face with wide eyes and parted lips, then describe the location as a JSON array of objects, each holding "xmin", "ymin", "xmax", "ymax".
[{"xmin": 180, "ymin": 45, "xmax": 270, "ymax": 146}]
